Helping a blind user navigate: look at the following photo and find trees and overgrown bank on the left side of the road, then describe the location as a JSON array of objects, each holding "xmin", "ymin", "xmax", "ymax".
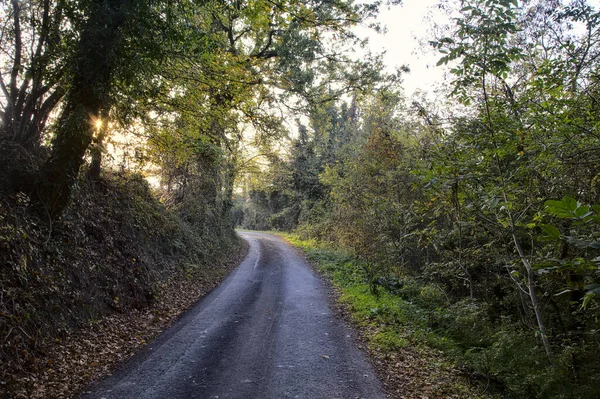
[{"xmin": 0, "ymin": 0, "xmax": 396, "ymax": 398}]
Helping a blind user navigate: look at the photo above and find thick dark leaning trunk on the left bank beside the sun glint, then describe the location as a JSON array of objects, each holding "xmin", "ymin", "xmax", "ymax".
[{"xmin": 37, "ymin": 0, "xmax": 126, "ymax": 218}]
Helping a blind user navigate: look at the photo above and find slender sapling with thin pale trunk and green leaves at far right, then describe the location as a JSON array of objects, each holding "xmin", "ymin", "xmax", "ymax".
[{"xmin": 433, "ymin": 0, "xmax": 599, "ymax": 363}]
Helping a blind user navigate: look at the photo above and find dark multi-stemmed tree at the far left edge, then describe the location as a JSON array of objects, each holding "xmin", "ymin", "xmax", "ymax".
[{"xmin": 0, "ymin": 0, "xmax": 80, "ymax": 191}]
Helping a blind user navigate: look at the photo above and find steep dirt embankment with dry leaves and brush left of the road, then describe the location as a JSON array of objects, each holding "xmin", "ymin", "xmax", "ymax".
[{"xmin": 0, "ymin": 174, "xmax": 243, "ymax": 398}]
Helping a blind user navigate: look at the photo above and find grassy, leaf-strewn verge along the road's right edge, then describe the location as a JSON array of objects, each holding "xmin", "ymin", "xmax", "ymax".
[{"xmin": 277, "ymin": 233, "xmax": 493, "ymax": 398}]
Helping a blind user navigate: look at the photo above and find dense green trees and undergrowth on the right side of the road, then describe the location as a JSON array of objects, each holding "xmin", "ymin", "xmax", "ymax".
[{"xmin": 232, "ymin": 0, "xmax": 600, "ymax": 398}]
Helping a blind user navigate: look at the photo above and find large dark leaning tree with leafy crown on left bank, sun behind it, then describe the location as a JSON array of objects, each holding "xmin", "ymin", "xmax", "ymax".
[{"xmin": 36, "ymin": 0, "xmax": 202, "ymax": 217}]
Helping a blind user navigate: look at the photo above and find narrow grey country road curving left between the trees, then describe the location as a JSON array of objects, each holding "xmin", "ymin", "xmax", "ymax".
[{"xmin": 84, "ymin": 232, "xmax": 385, "ymax": 399}]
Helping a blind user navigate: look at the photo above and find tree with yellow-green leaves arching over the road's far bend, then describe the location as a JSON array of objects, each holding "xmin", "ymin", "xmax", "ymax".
[{"xmin": 142, "ymin": 1, "xmax": 394, "ymax": 223}]
